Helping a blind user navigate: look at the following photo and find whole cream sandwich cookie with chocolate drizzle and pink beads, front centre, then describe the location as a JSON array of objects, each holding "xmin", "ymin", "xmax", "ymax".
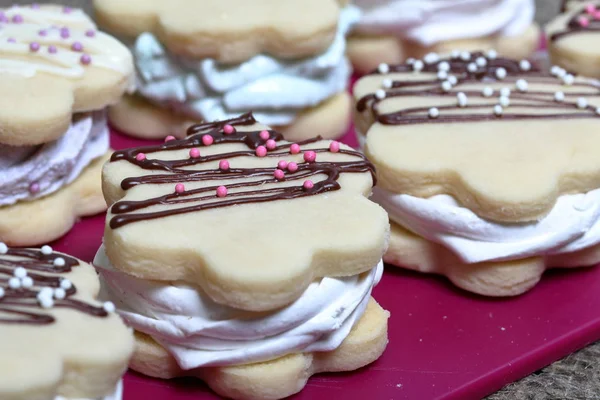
[{"xmin": 94, "ymin": 114, "xmax": 389, "ymax": 399}]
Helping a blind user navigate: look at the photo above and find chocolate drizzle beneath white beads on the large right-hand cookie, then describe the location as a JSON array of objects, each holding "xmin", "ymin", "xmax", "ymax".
[{"xmin": 356, "ymin": 52, "xmax": 600, "ymax": 125}]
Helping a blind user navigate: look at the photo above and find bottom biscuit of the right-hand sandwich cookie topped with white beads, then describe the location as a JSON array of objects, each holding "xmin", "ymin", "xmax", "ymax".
[{"xmin": 383, "ymin": 222, "xmax": 600, "ymax": 297}]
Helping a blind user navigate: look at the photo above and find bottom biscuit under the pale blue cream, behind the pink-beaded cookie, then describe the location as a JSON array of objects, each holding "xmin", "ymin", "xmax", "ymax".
[{"xmin": 108, "ymin": 92, "xmax": 352, "ymax": 141}]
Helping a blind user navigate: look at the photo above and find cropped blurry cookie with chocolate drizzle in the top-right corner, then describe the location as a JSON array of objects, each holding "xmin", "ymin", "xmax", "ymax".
[{"xmin": 546, "ymin": 1, "xmax": 600, "ymax": 78}]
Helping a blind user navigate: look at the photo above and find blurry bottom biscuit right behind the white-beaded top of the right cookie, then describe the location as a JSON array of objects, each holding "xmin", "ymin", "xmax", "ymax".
[{"xmin": 348, "ymin": 24, "xmax": 540, "ymax": 74}]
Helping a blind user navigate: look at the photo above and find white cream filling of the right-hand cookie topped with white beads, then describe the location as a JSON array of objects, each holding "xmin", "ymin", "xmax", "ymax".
[{"xmin": 372, "ymin": 188, "xmax": 600, "ymax": 263}]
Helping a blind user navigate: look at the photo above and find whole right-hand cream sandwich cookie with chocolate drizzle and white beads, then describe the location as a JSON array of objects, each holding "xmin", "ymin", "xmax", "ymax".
[{"xmin": 354, "ymin": 52, "xmax": 600, "ymax": 296}]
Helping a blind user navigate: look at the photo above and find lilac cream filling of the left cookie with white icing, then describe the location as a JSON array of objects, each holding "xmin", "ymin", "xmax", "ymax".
[{"xmin": 0, "ymin": 111, "xmax": 109, "ymax": 206}]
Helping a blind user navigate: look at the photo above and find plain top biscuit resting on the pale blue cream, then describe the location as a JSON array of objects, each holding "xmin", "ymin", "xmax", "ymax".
[{"xmin": 94, "ymin": 0, "xmax": 340, "ymax": 63}]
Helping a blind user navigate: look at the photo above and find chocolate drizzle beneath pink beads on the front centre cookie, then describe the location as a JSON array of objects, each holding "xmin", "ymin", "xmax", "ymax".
[{"xmin": 110, "ymin": 113, "xmax": 375, "ymax": 229}]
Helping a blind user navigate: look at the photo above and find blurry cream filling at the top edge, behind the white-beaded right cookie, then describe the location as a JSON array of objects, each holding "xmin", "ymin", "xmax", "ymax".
[{"xmin": 354, "ymin": 0, "xmax": 535, "ymax": 46}]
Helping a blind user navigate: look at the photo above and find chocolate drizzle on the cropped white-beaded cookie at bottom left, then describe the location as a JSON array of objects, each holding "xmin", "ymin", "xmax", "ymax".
[{"xmin": 0, "ymin": 249, "xmax": 108, "ymax": 325}]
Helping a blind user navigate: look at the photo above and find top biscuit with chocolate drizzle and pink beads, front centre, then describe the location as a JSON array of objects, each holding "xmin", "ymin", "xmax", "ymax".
[{"xmin": 103, "ymin": 114, "xmax": 389, "ymax": 311}]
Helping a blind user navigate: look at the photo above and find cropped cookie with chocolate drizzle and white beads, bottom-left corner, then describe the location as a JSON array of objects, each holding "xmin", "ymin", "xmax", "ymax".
[{"xmin": 0, "ymin": 242, "xmax": 135, "ymax": 400}]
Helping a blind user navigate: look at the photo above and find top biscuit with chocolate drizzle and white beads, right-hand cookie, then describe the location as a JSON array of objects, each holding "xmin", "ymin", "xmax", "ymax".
[{"xmin": 354, "ymin": 52, "xmax": 600, "ymax": 222}]
